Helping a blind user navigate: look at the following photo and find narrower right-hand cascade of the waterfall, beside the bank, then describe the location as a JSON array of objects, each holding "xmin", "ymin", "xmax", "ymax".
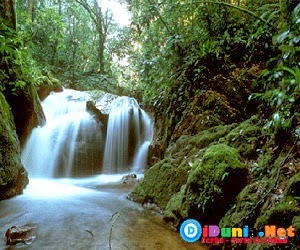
[{"xmin": 103, "ymin": 96, "xmax": 153, "ymax": 173}]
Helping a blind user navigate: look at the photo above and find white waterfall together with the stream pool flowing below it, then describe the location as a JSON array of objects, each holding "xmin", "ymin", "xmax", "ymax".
[{"xmin": 0, "ymin": 90, "xmax": 203, "ymax": 250}]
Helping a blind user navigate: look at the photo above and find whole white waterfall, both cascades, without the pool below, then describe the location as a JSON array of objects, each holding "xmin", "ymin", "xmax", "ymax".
[{"xmin": 22, "ymin": 89, "xmax": 153, "ymax": 178}]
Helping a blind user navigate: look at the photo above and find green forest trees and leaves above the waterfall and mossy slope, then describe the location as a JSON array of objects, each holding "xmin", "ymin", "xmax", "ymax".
[{"xmin": 0, "ymin": 0, "xmax": 300, "ymax": 137}]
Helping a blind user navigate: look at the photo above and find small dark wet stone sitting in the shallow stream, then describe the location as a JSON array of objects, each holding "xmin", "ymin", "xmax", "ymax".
[{"xmin": 5, "ymin": 225, "xmax": 36, "ymax": 245}]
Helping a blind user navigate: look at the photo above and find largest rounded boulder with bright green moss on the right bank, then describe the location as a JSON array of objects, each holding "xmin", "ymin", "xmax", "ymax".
[{"xmin": 164, "ymin": 144, "xmax": 248, "ymax": 226}]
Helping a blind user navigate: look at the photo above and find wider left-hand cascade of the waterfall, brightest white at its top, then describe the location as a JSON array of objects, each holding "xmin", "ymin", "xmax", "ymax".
[{"xmin": 22, "ymin": 90, "xmax": 103, "ymax": 178}]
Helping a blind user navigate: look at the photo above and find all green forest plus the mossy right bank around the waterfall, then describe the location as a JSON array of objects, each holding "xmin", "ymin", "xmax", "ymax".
[{"xmin": 0, "ymin": 0, "xmax": 300, "ymax": 247}]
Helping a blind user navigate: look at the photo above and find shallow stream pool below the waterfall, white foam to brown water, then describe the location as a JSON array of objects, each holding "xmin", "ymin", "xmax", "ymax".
[{"xmin": 0, "ymin": 175, "xmax": 203, "ymax": 250}]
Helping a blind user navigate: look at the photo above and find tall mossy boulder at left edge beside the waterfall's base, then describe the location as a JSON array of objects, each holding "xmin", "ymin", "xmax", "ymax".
[{"xmin": 0, "ymin": 92, "xmax": 28, "ymax": 200}]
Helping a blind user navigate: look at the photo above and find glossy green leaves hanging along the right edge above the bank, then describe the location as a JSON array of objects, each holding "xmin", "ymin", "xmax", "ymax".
[{"xmin": 249, "ymin": 2, "xmax": 300, "ymax": 138}]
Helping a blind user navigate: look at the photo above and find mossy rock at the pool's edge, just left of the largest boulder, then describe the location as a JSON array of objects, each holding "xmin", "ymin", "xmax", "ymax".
[{"xmin": 129, "ymin": 159, "xmax": 189, "ymax": 209}]
